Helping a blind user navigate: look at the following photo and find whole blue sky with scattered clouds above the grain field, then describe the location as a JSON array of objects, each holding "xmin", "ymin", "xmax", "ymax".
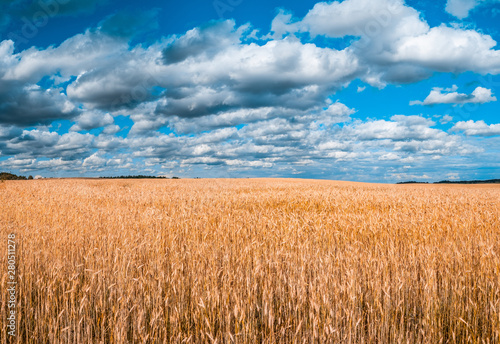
[{"xmin": 0, "ymin": 0, "xmax": 500, "ymax": 183}]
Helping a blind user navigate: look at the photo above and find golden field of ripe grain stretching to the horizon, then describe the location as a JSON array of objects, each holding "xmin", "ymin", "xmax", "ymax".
[{"xmin": 0, "ymin": 179, "xmax": 500, "ymax": 343}]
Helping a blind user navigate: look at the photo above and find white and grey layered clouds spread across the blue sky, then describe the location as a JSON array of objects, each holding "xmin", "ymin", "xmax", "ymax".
[{"xmin": 0, "ymin": 0, "xmax": 500, "ymax": 179}]
